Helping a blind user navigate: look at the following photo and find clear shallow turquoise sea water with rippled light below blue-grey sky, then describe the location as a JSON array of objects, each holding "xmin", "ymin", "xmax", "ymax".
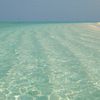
[{"xmin": 0, "ymin": 23, "xmax": 100, "ymax": 100}]
